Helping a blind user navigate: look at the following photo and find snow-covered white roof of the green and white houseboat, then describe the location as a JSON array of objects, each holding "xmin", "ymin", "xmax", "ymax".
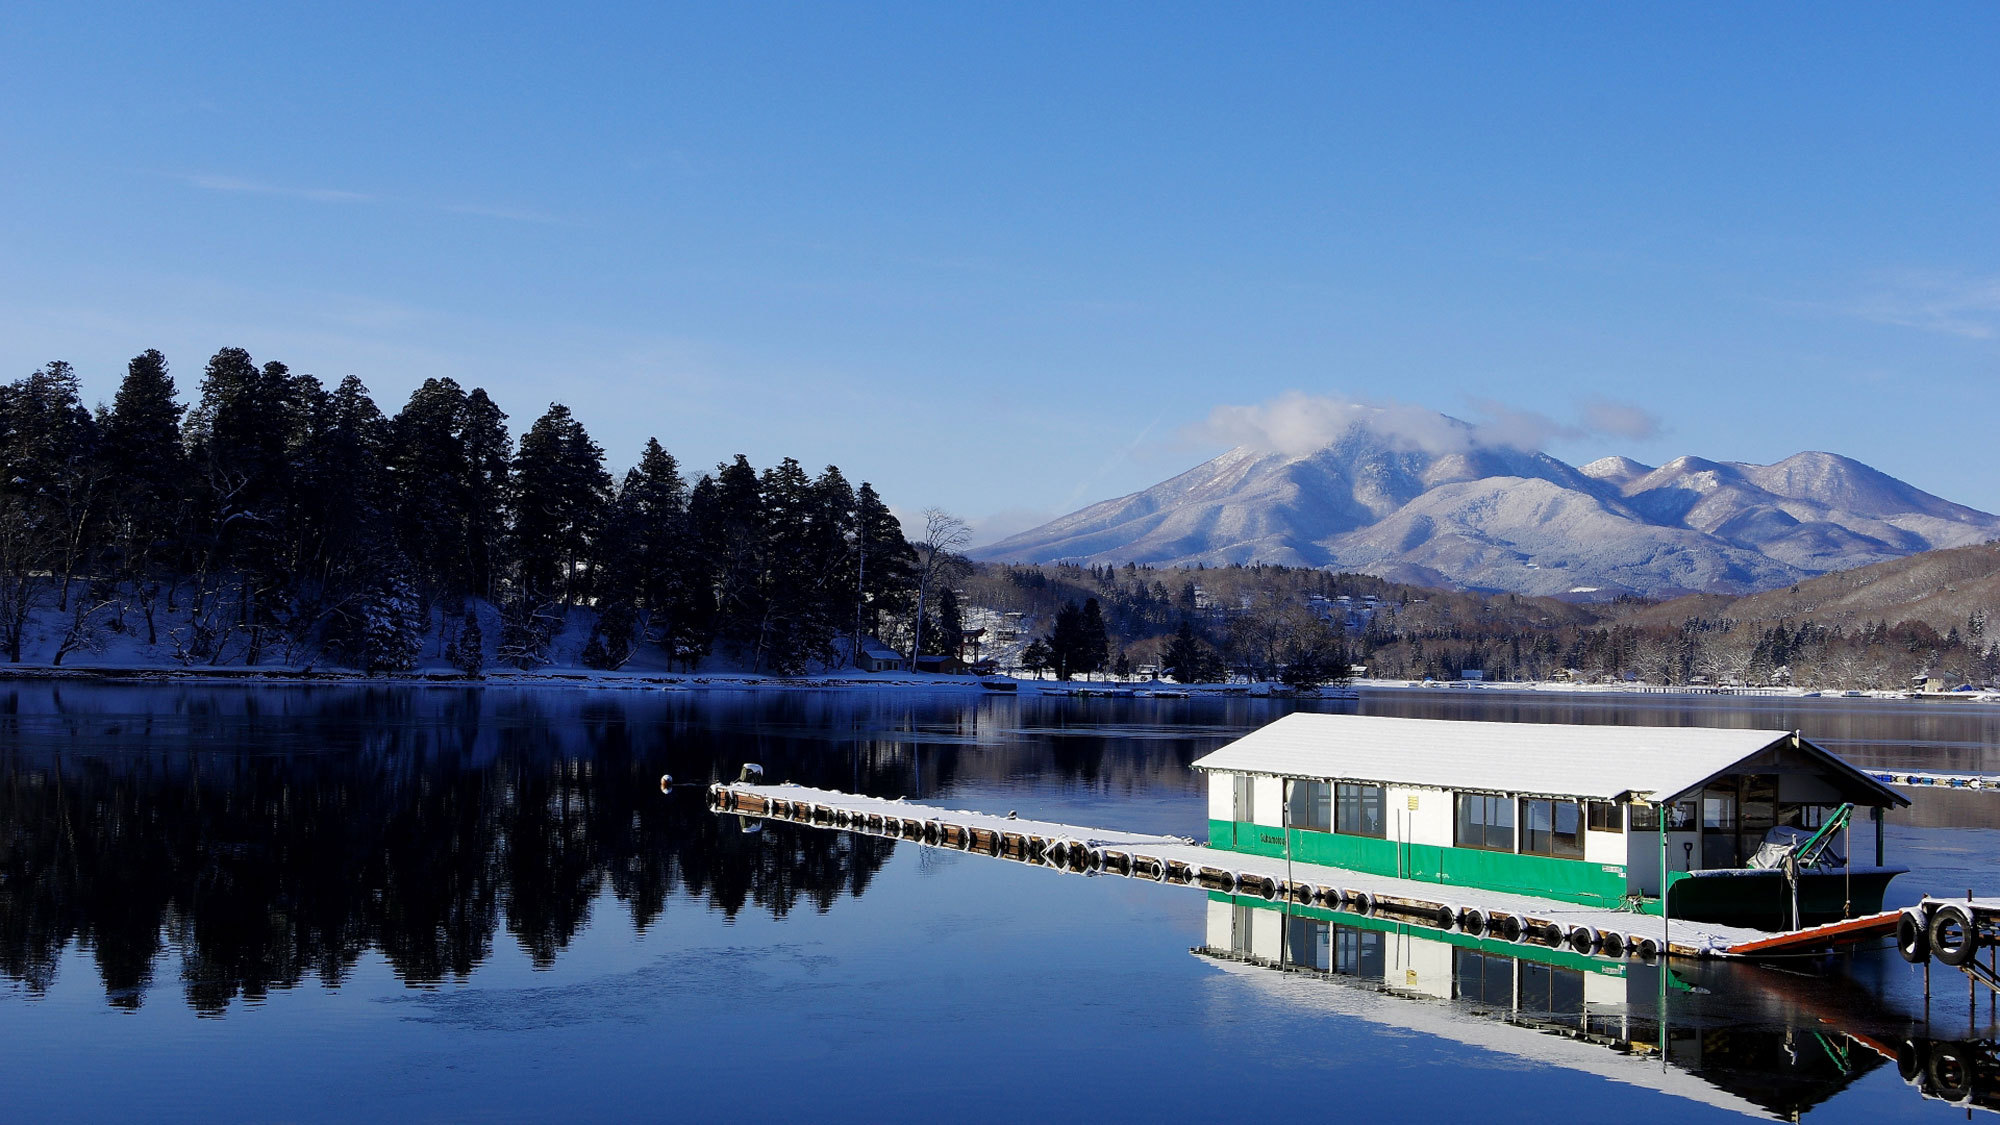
[{"xmin": 1194, "ymin": 713, "xmax": 1908, "ymax": 805}]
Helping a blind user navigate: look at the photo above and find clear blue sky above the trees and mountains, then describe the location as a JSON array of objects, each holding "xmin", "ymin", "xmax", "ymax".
[{"xmin": 0, "ymin": 0, "xmax": 2000, "ymax": 538}]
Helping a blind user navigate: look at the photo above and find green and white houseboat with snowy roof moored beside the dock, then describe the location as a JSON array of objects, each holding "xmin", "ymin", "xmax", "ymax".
[{"xmin": 1194, "ymin": 713, "xmax": 1910, "ymax": 931}]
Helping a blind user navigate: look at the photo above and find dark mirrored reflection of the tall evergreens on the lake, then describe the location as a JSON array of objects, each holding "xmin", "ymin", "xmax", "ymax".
[{"xmin": 0, "ymin": 680, "xmax": 956, "ymax": 1011}]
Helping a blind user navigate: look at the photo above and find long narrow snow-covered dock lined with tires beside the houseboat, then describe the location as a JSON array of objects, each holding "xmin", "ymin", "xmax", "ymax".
[{"xmin": 708, "ymin": 783, "xmax": 1776, "ymax": 959}]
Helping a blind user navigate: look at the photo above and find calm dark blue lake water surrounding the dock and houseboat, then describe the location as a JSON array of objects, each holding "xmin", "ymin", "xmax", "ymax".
[{"xmin": 0, "ymin": 685, "xmax": 2000, "ymax": 1121}]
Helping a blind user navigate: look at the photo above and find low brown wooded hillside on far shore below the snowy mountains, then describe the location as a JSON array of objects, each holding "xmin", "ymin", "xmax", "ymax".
[{"xmin": 964, "ymin": 544, "xmax": 2000, "ymax": 689}]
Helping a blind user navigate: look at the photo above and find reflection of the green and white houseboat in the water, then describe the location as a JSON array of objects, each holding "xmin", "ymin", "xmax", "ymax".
[{"xmin": 1196, "ymin": 895, "xmax": 1944, "ymax": 1121}]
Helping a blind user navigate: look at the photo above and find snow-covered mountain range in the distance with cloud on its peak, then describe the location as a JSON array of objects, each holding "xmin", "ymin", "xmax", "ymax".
[{"xmin": 972, "ymin": 406, "xmax": 2000, "ymax": 597}]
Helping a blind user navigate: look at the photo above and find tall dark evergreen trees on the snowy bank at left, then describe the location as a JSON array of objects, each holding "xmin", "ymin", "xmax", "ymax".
[{"xmin": 0, "ymin": 348, "xmax": 962, "ymax": 675}]
